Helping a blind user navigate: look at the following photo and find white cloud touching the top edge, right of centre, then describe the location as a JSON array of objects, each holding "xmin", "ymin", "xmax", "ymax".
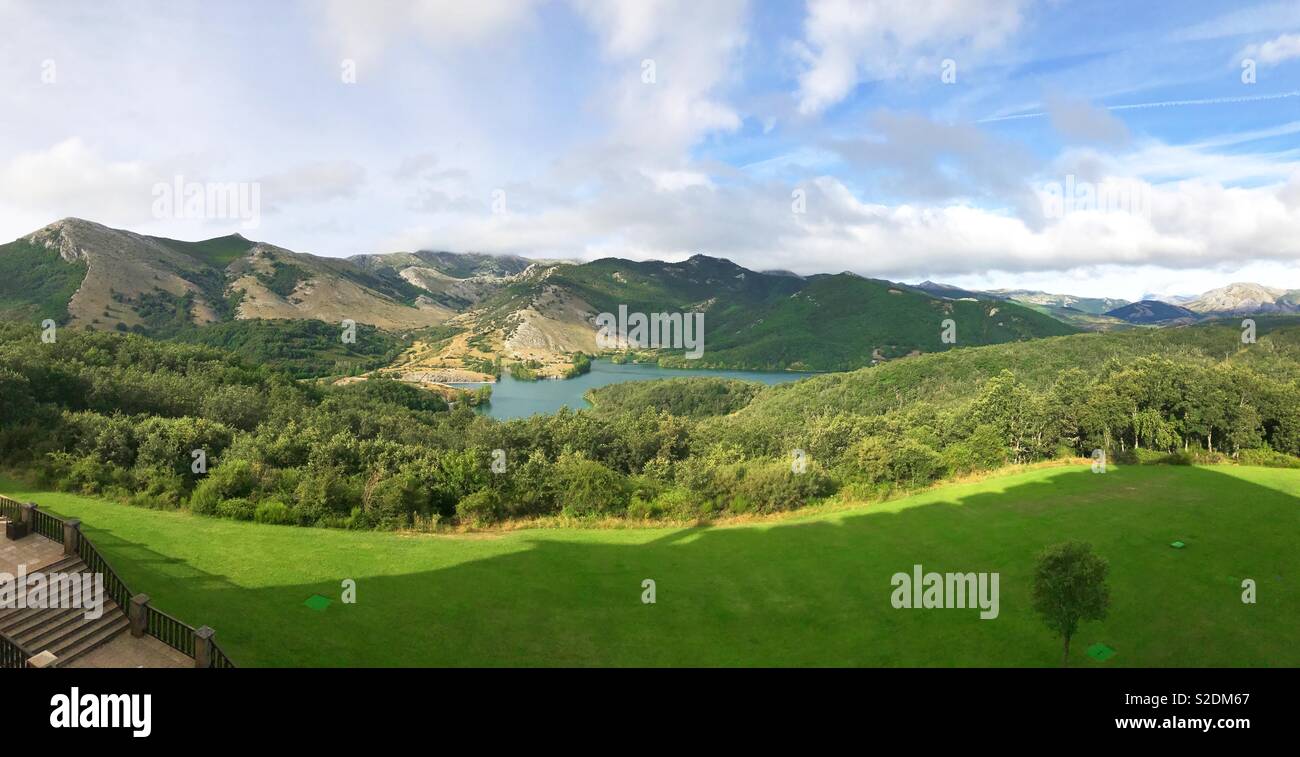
[{"xmin": 798, "ymin": 0, "xmax": 1026, "ymax": 114}]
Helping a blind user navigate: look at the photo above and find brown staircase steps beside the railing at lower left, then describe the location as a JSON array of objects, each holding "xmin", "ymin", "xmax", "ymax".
[{"xmin": 0, "ymin": 555, "xmax": 129, "ymax": 666}]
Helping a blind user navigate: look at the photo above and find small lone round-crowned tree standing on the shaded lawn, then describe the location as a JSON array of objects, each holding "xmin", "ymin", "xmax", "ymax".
[{"xmin": 1034, "ymin": 541, "xmax": 1110, "ymax": 667}]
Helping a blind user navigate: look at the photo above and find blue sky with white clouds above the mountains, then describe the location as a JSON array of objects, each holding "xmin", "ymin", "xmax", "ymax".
[{"xmin": 0, "ymin": 0, "xmax": 1300, "ymax": 299}]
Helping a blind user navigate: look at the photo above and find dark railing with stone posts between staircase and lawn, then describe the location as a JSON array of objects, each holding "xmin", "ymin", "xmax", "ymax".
[{"xmin": 0, "ymin": 496, "xmax": 235, "ymax": 669}]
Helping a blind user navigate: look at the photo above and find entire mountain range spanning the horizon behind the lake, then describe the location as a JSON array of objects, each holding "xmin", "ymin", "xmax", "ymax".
[{"xmin": 0, "ymin": 219, "xmax": 1300, "ymax": 382}]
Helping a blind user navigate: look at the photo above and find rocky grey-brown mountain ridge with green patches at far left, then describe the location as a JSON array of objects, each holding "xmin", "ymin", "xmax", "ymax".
[{"xmin": 0, "ymin": 219, "xmax": 454, "ymax": 332}]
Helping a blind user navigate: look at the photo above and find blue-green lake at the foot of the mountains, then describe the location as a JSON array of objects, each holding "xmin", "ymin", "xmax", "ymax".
[{"xmin": 451, "ymin": 360, "xmax": 813, "ymax": 420}]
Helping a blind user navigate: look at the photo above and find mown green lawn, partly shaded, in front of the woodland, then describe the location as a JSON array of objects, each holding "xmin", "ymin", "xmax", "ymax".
[{"xmin": 0, "ymin": 466, "xmax": 1300, "ymax": 667}]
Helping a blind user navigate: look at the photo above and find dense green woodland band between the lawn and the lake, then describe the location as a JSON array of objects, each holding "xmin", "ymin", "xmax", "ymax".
[{"xmin": 0, "ymin": 317, "xmax": 1300, "ymax": 528}]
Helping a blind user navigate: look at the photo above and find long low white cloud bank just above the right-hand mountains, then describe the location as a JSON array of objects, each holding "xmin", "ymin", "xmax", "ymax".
[{"xmin": 384, "ymin": 157, "xmax": 1300, "ymax": 291}]
